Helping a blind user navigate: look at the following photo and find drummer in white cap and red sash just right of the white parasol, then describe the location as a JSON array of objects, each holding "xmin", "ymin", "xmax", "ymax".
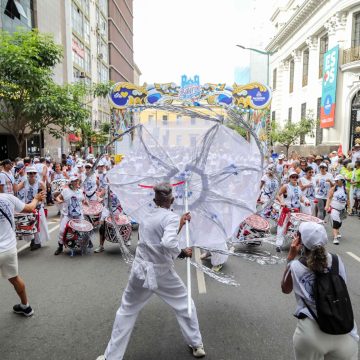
[{"xmin": 276, "ymin": 170, "xmax": 310, "ymax": 252}]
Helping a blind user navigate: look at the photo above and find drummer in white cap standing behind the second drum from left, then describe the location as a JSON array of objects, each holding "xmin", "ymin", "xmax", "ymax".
[{"xmin": 54, "ymin": 175, "xmax": 92, "ymax": 255}]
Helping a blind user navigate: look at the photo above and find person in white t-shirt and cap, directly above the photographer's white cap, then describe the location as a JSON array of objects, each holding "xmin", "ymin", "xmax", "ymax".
[{"xmin": 315, "ymin": 163, "xmax": 334, "ymax": 220}]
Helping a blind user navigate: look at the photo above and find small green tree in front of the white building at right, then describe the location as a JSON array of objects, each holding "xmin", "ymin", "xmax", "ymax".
[{"xmin": 270, "ymin": 111, "xmax": 315, "ymax": 156}]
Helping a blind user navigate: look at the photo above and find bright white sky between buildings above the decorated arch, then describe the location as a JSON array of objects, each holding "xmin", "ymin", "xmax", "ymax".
[{"xmin": 134, "ymin": 0, "xmax": 274, "ymax": 84}]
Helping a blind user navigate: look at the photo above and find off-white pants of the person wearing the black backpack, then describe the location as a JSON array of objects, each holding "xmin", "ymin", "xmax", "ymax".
[{"xmin": 293, "ymin": 318, "xmax": 358, "ymax": 360}]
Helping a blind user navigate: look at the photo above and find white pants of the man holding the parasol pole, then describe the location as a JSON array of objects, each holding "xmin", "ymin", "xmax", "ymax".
[{"xmin": 105, "ymin": 268, "xmax": 202, "ymax": 360}]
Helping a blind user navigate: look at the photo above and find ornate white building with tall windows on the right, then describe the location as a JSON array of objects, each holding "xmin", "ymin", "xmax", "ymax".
[{"xmin": 266, "ymin": 0, "xmax": 360, "ymax": 152}]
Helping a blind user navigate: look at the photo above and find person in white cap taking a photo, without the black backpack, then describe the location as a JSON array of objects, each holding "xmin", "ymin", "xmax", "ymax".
[{"xmin": 281, "ymin": 222, "xmax": 359, "ymax": 360}]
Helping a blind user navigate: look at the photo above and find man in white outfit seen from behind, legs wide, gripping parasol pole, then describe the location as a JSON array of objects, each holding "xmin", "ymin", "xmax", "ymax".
[{"xmin": 98, "ymin": 184, "xmax": 206, "ymax": 360}]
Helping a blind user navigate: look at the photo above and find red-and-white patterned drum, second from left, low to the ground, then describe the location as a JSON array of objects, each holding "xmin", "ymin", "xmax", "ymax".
[{"xmin": 63, "ymin": 219, "xmax": 94, "ymax": 249}]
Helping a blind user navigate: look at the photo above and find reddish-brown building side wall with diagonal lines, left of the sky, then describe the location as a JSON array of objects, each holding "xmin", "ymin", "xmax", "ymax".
[{"xmin": 108, "ymin": 0, "xmax": 135, "ymax": 83}]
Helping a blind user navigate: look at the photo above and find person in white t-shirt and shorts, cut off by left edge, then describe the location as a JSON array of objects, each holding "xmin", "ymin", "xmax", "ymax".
[{"xmin": 0, "ymin": 192, "xmax": 45, "ymax": 316}]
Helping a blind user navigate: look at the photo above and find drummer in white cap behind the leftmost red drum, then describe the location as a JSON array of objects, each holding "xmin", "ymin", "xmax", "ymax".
[{"xmin": 18, "ymin": 166, "xmax": 50, "ymax": 251}]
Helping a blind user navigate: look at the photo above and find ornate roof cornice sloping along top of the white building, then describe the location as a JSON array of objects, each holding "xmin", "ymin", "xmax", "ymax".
[{"xmin": 266, "ymin": 0, "xmax": 329, "ymax": 51}]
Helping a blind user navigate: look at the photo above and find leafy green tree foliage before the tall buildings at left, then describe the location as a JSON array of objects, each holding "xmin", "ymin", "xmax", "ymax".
[{"xmin": 0, "ymin": 30, "xmax": 112, "ymax": 153}]
